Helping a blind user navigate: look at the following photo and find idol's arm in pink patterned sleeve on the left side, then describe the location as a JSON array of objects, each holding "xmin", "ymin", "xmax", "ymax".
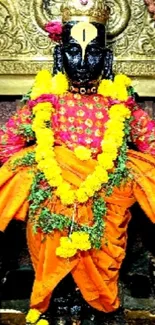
[{"xmin": 0, "ymin": 106, "xmax": 34, "ymax": 163}]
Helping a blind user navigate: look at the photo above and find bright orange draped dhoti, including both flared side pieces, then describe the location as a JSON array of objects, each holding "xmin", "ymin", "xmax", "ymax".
[{"xmin": 0, "ymin": 146, "xmax": 155, "ymax": 312}]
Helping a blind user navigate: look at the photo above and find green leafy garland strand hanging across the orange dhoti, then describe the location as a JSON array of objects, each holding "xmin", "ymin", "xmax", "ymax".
[{"xmin": 30, "ymin": 192, "xmax": 107, "ymax": 249}]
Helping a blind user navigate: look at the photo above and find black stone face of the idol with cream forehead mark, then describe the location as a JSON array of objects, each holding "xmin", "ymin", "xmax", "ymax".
[{"xmin": 62, "ymin": 22, "xmax": 105, "ymax": 92}]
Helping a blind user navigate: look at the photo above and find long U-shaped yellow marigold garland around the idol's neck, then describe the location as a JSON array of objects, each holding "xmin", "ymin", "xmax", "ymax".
[{"xmin": 32, "ymin": 72, "xmax": 131, "ymax": 205}]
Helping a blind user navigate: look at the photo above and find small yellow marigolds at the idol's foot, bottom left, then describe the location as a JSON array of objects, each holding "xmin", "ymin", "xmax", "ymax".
[{"xmin": 26, "ymin": 309, "xmax": 49, "ymax": 325}]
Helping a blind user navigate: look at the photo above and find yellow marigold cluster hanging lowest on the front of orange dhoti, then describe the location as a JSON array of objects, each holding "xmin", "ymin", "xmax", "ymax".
[{"xmin": 56, "ymin": 231, "xmax": 91, "ymax": 258}]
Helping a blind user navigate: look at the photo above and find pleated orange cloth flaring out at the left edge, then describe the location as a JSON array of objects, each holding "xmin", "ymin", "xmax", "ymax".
[{"xmin": 0, "ymin": 148, "xmax": 34, "ymax": 231}]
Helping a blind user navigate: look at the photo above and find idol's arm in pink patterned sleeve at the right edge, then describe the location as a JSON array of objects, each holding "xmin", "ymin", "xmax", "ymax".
[{"xmin": 131, "ymin": 108, "xmax": 155, "ymax": 155}]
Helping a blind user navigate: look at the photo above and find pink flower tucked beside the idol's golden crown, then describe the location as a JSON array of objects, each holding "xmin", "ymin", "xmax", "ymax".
[{"xmin": 45, "ymin": 20, "xmax": 62, "ymax": 42}]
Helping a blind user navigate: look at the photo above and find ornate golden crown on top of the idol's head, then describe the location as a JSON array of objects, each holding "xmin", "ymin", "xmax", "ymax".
[{"xmin": 61, "ymin": 0, "xmax": 109, "ymax": 24}]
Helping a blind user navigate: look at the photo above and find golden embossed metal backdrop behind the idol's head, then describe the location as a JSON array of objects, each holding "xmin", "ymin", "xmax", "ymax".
[{"xmin": 0, "ymin": 0, "xmax": 155, "ymax": 97}]
